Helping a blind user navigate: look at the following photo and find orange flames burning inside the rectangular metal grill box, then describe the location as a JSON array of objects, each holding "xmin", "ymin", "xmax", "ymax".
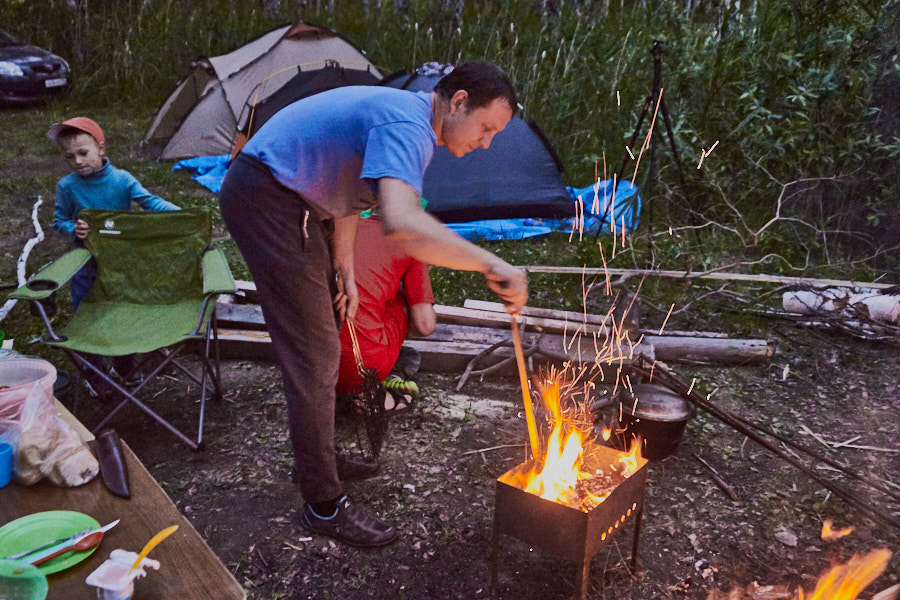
[{"xmin": 502, "ymin": 373, "xmax": 647, "ymax": 512}]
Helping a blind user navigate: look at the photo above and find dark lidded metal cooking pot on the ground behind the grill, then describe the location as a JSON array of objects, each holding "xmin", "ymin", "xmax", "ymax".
[{"xmin": 615, "ymin": 383, "xmax": 697, "ymax": 460}]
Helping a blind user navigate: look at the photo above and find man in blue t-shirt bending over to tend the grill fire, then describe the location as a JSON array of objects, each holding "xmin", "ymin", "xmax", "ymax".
[{"xmin": 219, "ymin": 61, "xmax": 528, "ymax": 547}]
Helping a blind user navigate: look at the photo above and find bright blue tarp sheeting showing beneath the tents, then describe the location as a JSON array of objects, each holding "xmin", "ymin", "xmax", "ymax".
[{"xmin": 172, "ymin": 154, "xmax": 641, "ymax": 240}]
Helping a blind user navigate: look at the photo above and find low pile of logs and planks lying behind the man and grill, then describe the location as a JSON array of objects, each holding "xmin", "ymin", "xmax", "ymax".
[{"xmin": 216, "ymin": 281, "xmax": 772, "ymax": 374}]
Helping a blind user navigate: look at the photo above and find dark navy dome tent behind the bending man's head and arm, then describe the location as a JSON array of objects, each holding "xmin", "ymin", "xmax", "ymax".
[{"xmin": 383, "ymin": 73, "xmax": 574, "ymax": 223}]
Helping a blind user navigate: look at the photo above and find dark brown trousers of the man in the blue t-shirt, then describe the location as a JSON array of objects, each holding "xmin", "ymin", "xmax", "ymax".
[{"xmin": 219, "ymin": 154, "xmax": 343, "ymax": 503}]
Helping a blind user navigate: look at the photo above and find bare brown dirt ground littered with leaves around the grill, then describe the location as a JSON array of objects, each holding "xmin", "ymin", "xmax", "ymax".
[{"xmin": 0, "ymin": 109, "xmax": 900, "ymax": 600}]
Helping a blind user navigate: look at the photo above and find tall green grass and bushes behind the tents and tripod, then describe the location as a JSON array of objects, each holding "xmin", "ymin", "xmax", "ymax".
[{"xmin": 0, "ymin": 0, "xmax": 900, "ymax": 270}]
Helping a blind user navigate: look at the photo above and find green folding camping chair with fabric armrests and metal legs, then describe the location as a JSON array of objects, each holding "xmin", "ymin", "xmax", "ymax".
[{"xmin": 10, "ymin": 209, "xmax": 237, "ymax": 449}]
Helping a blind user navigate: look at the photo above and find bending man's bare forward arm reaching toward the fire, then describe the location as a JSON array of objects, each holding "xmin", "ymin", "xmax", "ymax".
[{"xmin": 378, "ymin": 177, "xmax": 528, "ymax": 313}]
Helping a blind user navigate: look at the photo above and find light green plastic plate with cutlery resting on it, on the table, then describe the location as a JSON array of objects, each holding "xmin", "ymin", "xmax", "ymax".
[{"xmin": 0, "ymin": 510, "xmax": 100, "ymax": 575}]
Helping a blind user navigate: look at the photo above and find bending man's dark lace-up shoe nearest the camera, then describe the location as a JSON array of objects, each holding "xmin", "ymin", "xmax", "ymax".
[{"xmin": 300, "ymin": 496, "xmax": 397, "ymax": 548}]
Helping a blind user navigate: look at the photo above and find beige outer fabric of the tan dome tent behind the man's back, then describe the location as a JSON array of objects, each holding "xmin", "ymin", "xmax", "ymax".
[{"xmin": 144, "ymin": 22, "xmax": 381, "ymax": 160}]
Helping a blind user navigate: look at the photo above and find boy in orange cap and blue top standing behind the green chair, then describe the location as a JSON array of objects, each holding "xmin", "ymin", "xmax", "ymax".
[{"xmin": 47, "ymin": 117, "xmax": 178, "ymax": 393}]
